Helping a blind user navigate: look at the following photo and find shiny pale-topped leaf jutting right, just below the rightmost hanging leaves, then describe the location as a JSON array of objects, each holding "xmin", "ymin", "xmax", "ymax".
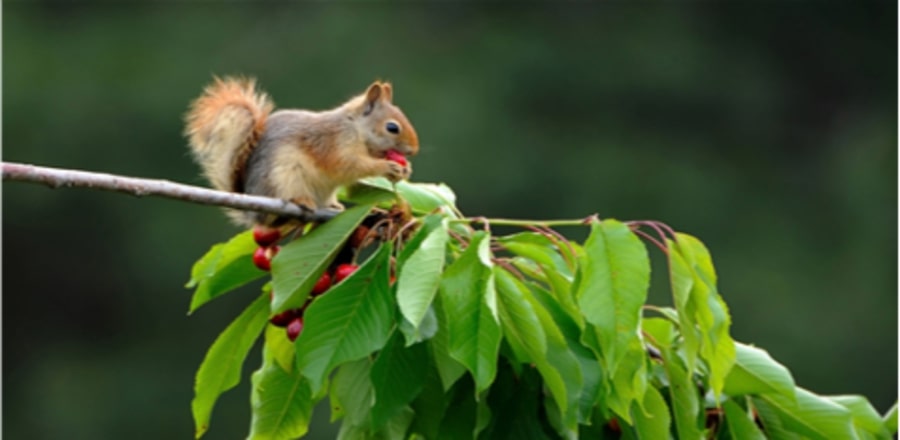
[{"xmin": 724, "ymin": 344, "xmax": 795, "ymax": 399}]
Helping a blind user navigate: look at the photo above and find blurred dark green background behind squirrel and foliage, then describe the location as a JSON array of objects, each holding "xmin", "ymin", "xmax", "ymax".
[{"xmin": 2, "ymin": 1, "xmax": 898, "ymax": 439}]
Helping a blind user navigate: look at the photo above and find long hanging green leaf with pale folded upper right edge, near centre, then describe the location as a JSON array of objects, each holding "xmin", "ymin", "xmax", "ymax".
[{"xmin": 440, "ymin": 231, "xmax": 500, "ymax": 392}]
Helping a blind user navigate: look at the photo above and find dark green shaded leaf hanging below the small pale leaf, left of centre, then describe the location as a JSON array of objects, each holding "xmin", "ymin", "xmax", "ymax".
[{"xmin": 371, "ymin": 332, "xmax": 429, "ymax": 430}]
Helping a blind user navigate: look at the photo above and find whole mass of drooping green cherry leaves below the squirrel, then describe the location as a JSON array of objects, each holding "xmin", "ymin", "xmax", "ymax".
[{"xmin": 183, "ymin": 179, "xmax": 896, "ymax": 439}]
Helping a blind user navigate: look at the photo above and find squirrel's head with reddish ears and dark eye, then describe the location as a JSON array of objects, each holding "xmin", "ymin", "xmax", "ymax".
[{"xmin": 358, "ymin": 81, "xmax": 419, "ymax": 157}]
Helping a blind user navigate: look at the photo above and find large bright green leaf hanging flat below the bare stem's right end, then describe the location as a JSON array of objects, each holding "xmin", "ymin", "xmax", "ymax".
[{"xmin": 576, "ymin": 220, "xmax": 650, "ymax": 377}]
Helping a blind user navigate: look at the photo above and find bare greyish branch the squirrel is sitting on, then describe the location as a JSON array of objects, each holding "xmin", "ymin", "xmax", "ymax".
[{"xmin": 2, "ymin": 162, "xmax": 335, "ymax": 222}]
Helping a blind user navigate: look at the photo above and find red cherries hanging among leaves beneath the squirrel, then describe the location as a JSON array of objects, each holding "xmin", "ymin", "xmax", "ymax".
[{"xmin": 253, "ymin": 227, "xmax": 359, "ymax": 342}]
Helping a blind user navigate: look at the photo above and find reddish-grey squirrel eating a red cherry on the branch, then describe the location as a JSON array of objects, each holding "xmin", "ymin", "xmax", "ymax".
[{"xmin": 185, "ymin": 77, "xmax": 419, "ymax": 227}]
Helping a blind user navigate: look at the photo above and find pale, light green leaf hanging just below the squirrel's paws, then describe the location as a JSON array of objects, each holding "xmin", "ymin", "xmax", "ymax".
[{"xmin": 397, "ymin": 220, "xmax": 449, "ymax": 344}]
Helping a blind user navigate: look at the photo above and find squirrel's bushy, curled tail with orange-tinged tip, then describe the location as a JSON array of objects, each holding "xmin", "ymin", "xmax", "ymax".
[{"xmin": 185, "ymin": 77, "xmax": 275, "ymax": 192}]
